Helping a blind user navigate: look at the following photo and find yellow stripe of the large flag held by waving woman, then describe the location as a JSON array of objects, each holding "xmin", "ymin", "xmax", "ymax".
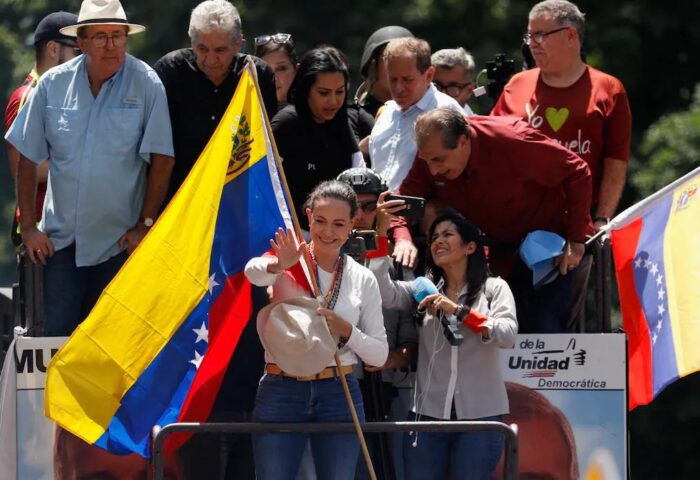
[{"xmin": 45, "ymin": 68, "xmax": 265, "ymax": 443}]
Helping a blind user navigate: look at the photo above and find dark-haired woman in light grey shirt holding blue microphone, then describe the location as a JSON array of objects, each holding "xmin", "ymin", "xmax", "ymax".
[{"xmin": 372, "ymin": 209, "xmax": 518, "ymax": 480}]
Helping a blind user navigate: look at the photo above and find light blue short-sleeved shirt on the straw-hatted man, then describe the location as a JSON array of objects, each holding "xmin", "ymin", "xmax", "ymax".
[{"xmin": 5, "ymin": 55, "xmax": 173, "ymax": 267}]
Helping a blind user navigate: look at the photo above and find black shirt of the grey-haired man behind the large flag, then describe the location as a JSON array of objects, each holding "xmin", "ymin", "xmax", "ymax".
[{"xmin": 153, "ymin": 48, "xmax": 277, "ymax": 199}]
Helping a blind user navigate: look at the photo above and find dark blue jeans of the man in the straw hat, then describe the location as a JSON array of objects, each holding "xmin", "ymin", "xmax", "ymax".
[{"xmin": 44, "ymin": 244, "xmax": 127, "ymax": 337}]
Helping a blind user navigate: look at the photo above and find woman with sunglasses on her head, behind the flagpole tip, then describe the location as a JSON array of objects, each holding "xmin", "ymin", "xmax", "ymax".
[{"xmin": 255, "ymin": 33, "xmax": 298, "ymax": 110}]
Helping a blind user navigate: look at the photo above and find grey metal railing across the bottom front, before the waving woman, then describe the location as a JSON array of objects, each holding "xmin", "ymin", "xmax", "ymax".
[{"xmin": 153, "ymin": 421, "xmax": 518, "ymax": 480}]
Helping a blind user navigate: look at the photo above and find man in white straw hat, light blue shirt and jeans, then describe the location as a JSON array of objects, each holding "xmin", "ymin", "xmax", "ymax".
[{"xmin": 6, "ymin": 0, "xmax": 174, "ymax": 336}]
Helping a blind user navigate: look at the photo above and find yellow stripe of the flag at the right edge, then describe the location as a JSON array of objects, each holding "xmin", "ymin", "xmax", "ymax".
[{"xmin": 664, "ymin": 177, "xmax": 700, "ymax": 377}]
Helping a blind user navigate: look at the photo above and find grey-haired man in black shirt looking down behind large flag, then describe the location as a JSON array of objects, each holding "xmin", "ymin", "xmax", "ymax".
[{"xmin": 154, "ymin": 0, "xmax": 277, "ymax": 198}]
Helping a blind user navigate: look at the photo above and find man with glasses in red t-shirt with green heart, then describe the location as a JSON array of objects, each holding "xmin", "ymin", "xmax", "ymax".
[{"xmin": 491, "ymin": 0, "xmax": 632, "ymax": 329}]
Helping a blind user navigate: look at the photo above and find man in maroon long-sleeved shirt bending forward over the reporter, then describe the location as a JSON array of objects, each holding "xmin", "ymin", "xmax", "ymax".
[{"xmin": 392, "ymin": 109, "xmax": 593, "ymax": 333}]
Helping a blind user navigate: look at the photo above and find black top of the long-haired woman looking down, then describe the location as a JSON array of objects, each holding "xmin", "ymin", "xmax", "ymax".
[{"xmin": 272, "ymin": 105, "xmax": 359, "ymax": 216}]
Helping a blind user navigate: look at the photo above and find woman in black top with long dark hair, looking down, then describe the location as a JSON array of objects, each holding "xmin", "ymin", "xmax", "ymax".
[{"xmin": 272, "ymin": 47, "xmax": 365, "ymax": 216}]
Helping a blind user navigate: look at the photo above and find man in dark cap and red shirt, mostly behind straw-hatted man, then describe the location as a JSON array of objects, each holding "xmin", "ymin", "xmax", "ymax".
[{"xmin": 5, "ymin": 12, "xmax": 80, "ymax": 246}]
